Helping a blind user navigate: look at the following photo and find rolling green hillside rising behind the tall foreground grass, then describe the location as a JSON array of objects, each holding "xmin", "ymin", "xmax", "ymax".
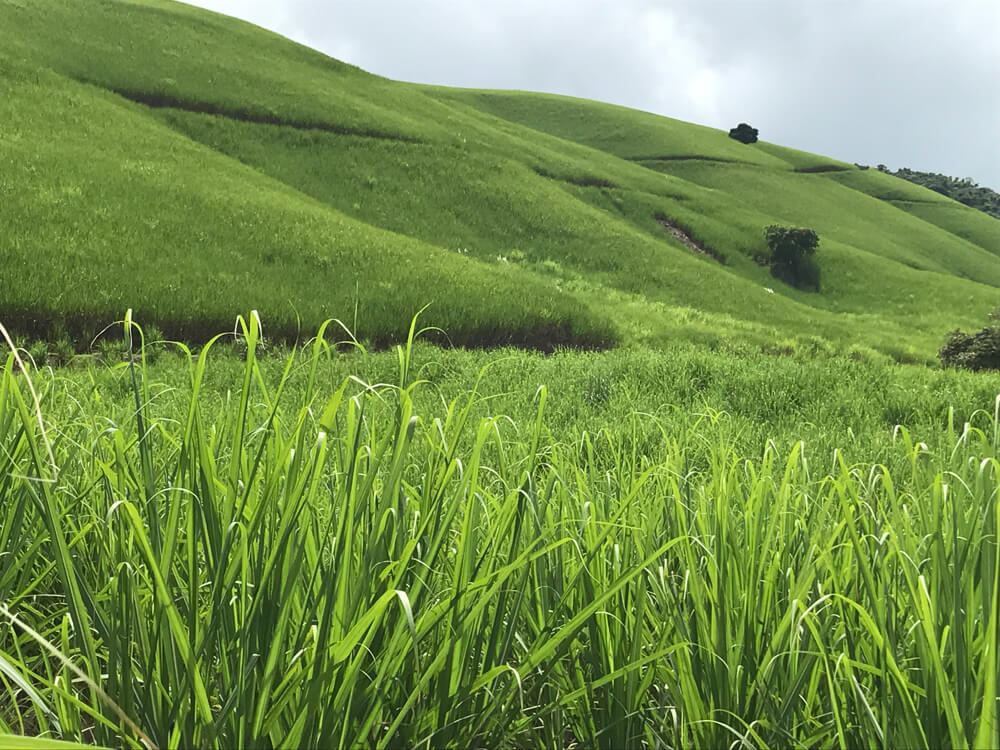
[{"xmin": 0, "ymin": 0, "xmax": 1000, "ymax": 361}]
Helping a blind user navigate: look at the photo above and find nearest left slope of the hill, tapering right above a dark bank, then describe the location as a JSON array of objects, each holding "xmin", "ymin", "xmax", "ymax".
[{"xmin": 0, "ymin": 62, "xmax": 603, "ymax": 345}]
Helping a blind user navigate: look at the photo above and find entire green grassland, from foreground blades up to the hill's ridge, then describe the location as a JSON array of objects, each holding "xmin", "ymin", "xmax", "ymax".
[{"xmin": 0, "ymin": 0, "xmax": 1000, "ymax": 750}]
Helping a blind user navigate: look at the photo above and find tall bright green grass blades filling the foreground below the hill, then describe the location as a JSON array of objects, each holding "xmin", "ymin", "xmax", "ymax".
[{"xmin": 0, "ymin": 320, "xmax": 1000, "ymax": 747}]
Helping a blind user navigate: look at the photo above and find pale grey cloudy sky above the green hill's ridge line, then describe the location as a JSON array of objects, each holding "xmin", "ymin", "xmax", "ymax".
[{"xmin": 194, "ymin": 0, "xmax": 1000, "ymax": 190}]
